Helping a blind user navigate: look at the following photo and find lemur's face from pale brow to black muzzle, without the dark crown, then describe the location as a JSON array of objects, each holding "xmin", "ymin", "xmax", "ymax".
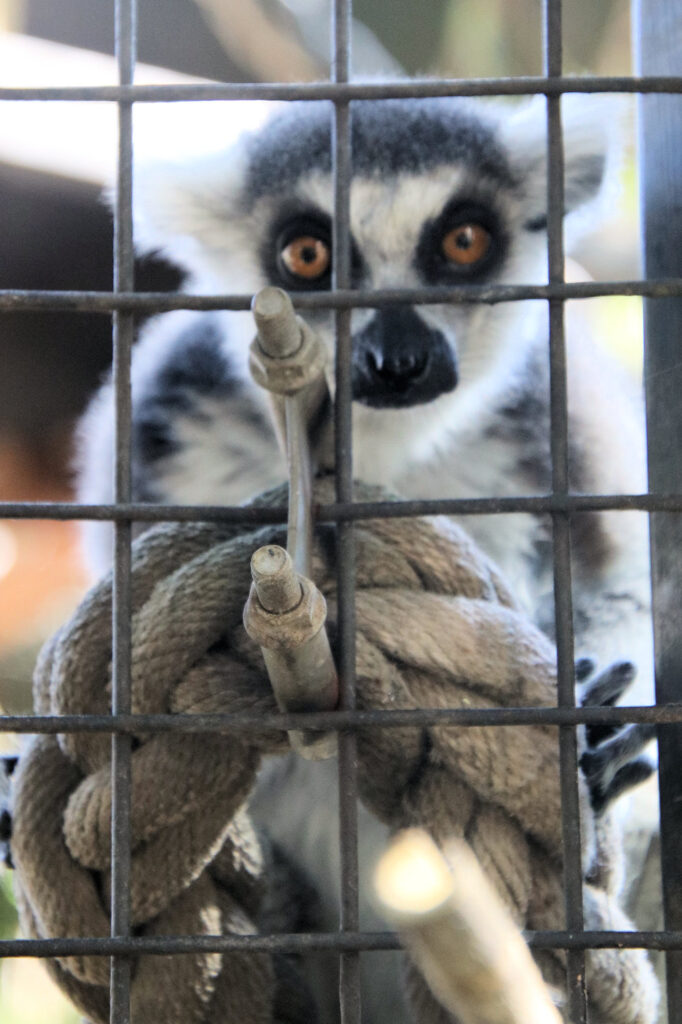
[{"xmin": 260, "ymin": 165, "xmax": 510, "ymax": 410}]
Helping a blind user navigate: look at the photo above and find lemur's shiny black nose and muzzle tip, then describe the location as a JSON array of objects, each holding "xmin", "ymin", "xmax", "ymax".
[{"xmin": 353, "ymin": 308, "xmax": 457, "ymax": 409}]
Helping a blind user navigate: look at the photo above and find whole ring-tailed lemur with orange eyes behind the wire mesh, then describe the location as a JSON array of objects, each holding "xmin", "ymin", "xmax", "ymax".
[{"xmin": 74, "ymin": 97, "xmax": 650, "ymax": 1022}]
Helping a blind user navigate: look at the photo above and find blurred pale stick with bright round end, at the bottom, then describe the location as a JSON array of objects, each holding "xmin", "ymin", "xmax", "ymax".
[{"xmin": 374, "ymin": 828, "xmax": 561, "ymax": 1024}]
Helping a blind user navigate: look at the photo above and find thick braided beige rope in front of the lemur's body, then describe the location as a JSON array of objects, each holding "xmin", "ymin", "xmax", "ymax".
[{"xmin": 12, "ymin": 481, "xmax": 655, "ymax": 1024}]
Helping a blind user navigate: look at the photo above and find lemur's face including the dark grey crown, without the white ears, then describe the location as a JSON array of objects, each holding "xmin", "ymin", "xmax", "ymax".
[{"xmin": 241, "ymin": 102, "xmax": 537, "ymax": 428}]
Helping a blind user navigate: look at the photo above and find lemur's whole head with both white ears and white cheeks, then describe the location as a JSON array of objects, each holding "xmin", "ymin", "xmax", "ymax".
[{"xmin": 136, "ymin": 96, "xmax": 608, "ymax": 477}]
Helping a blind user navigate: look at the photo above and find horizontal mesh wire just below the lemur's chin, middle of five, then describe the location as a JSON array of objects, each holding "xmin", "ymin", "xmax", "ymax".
[{"xmin": 0, "ymin": 494, "xmax": 682, "ymax": 525}]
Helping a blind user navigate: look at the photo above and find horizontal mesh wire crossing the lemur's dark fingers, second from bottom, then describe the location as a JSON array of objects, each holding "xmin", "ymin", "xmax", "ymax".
[{"xmin": 0, "ymin": 705, "xmax": 682, "ymax": 734}]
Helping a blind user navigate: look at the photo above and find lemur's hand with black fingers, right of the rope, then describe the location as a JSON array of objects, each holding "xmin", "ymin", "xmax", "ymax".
[{"xmin": 576, "ymin": 657, "xmax": 655, "ymax": 815}]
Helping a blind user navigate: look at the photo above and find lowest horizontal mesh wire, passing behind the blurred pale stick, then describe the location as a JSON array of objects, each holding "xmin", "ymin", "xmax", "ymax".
[{"xmin": 0, "ymin": 931, "xmax": 682, "ymax": 958}]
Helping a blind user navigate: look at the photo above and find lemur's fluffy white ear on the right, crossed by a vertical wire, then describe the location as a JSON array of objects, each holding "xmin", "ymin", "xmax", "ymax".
[{"xmin": 502, "ymin": 93, "xmax": 625, "ymax": 237}]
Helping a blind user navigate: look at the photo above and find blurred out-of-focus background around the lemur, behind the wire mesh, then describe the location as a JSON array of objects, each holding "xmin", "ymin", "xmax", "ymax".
[{"xmin": 0, "ymin": 0, "xmax": 641, "ymax": 1024}]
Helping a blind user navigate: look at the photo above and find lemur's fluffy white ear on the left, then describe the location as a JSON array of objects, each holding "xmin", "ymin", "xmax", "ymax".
[{"xmin": 133, "ymin": 143, "xmax": 246, "ymax": 264}]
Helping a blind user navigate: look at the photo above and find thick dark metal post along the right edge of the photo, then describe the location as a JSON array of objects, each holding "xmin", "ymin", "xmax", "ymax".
[{"xmin": 633, "ymin": 0, "xmax": 682, "ymax": 1021}]
